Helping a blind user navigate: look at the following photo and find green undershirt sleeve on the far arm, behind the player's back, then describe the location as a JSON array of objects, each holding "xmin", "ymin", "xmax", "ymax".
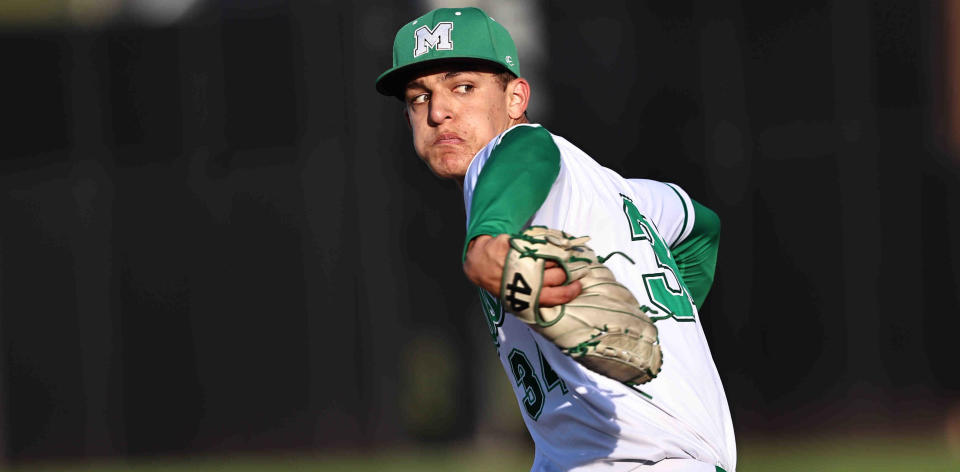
[{"xmin": 670, "ymin": 199, "xmax": 720, "ymax": 308}]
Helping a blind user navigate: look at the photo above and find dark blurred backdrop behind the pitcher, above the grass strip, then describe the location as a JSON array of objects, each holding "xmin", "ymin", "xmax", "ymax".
[{"xmin": 0, "ymin": 0, "xmax": 960, "ymax": 463}]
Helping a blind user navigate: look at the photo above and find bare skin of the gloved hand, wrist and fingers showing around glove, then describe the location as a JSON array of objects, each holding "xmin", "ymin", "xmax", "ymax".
[{"xmin": 463, "ymin": 234, "xmax": 583, "ymax": 307}]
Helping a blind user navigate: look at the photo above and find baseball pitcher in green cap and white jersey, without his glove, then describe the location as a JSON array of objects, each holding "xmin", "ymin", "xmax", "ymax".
[{"xmin": 376, "ymin": 8, "xmax": 736, "ymax": 472}]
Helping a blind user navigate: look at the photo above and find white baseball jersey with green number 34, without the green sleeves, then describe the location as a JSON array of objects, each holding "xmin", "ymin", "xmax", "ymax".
[{"xmin": 463, "ymin": 125, "xmax": 736, "ymax": 472}]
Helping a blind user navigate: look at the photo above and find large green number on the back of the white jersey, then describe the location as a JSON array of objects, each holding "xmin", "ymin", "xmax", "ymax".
[{"xmin": 620, "ymin": 194, "xmax": 696, "ymax": 321}]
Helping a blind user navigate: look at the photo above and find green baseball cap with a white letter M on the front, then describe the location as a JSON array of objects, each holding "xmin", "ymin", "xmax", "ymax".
[{"xmin": 377, "ymin": 7, "xmax": 520, "ymax": 96}]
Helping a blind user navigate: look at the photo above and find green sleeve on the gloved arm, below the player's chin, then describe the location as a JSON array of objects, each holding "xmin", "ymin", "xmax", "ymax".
[{"xmin": 463, "ymin": 126, "xmax": 560, "ymax": 259}]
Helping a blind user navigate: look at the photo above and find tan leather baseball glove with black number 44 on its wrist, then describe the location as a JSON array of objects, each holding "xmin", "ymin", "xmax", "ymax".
[{"xmin": 500, "ymin": 226, "xmax": 662, "ymax": 384}]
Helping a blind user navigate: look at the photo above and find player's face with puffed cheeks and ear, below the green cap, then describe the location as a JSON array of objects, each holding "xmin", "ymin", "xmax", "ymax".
[{"xmin": 404, "ymin": 70, "xmax": 514, "ymax": 182}]
